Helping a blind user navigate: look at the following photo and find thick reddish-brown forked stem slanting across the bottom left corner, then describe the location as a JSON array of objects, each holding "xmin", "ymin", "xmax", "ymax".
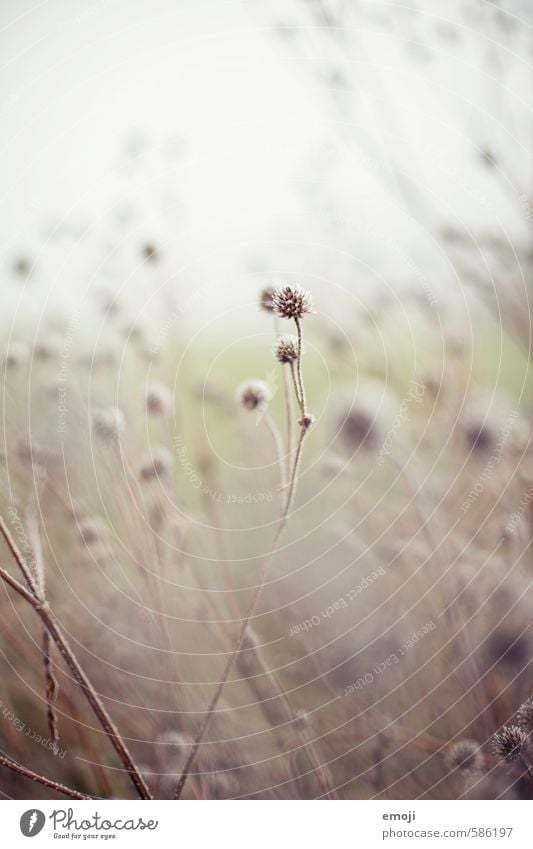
[{"xmin": 0, "ymin": 516, "xmax": 152, "ymax": 799}]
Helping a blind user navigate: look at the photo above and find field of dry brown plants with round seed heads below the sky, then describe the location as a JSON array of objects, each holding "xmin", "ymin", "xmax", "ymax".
[{"xmin": 0, "ymin": 250, "xmax": 533, "ymax": 799}]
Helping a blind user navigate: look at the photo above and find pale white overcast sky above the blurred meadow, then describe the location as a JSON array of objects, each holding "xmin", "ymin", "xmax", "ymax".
[{"xmin": 0, "ymin": 0, "xmax": 533, "ymax": 342}]
